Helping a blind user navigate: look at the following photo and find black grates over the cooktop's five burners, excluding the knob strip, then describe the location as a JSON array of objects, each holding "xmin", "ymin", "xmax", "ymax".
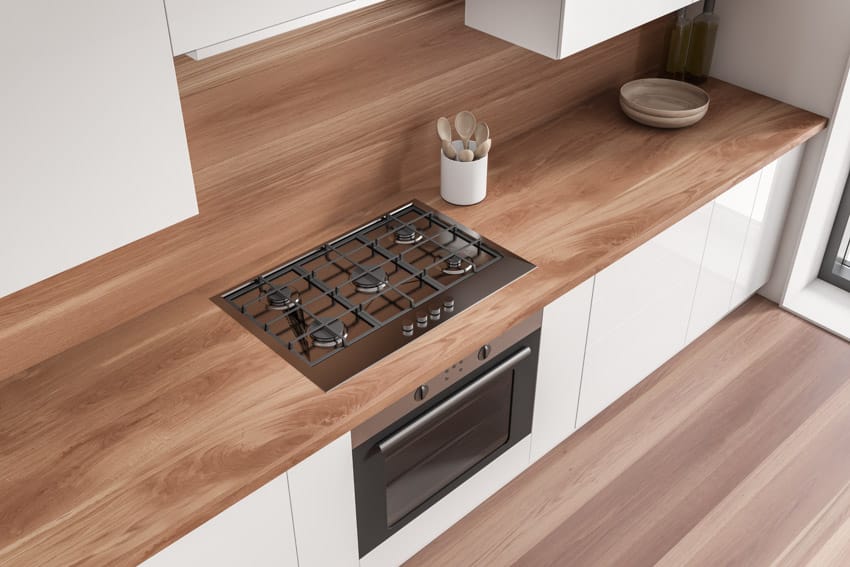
[{"xmin": 222, "ymin": 203, "xmax": 503, "ymax": 366}]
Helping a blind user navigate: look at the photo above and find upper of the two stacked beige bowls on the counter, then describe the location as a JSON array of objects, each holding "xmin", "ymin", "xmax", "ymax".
[{"xmin": 620, "ymin": 79, "xmax": 711, "ymax": 118}]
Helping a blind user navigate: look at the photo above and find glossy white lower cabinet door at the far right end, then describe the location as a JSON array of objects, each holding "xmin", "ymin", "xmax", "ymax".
[{"xmin": 732, "ymin": 151, "xmax": 803, "ymax": 308}]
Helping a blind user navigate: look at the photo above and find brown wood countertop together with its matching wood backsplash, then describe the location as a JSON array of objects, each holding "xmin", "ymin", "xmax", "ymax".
[{"xmin": 0, "ymin": 0, "xmax": 826, "ymax": 565}]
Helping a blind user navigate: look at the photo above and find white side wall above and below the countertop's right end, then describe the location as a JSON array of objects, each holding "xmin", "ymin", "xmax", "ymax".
[{"xmin": 712, "ymin": 0, "xmax": 850, "ymax": 302}]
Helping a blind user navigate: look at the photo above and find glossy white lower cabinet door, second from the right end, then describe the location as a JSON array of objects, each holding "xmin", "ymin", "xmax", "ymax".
[{"xmin": 686, "ymin": 171, "xmax": 762, "ymax": 343}]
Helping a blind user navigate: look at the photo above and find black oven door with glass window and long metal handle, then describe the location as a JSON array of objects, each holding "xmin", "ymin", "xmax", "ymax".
[{"xmin": 354, "ymin": 330, "xmax": 537, "ymax": 556}]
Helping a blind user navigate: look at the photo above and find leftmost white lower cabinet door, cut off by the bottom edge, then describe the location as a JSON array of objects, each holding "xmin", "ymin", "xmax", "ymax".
[{"xmin": 142, "ymin": 474, "xmax": 298, "ymax": 567}]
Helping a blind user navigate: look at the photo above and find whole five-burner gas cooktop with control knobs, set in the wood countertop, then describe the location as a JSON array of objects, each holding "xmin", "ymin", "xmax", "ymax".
[{"xmin": 213, "ymin": 201, "xmax": 534, "ymax": 391}]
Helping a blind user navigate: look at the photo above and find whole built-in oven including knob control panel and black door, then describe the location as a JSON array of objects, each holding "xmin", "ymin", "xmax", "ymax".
[{"xmin": 352, "ymin": 313, "xmax": 542, "ymax": 557}]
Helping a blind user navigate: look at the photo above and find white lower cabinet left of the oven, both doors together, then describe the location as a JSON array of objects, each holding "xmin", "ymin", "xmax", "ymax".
[{"xmin": 142, "ymin": 434, "xmax": 358, "ymax": 567}]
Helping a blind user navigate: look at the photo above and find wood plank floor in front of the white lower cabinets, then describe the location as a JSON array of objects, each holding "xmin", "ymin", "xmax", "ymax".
[{"xmin": 409, "ymin": 299, "xmax": 850, "ymax": 567}]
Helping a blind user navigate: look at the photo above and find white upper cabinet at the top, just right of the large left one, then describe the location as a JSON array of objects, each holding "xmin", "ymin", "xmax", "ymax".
[{"xmin": 165, "ymin": 0, "xmax": 351, "ymax": 55}]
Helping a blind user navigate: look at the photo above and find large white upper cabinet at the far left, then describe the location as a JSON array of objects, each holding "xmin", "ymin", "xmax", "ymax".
[{"xmin": 0, "ymin": 0, "xmax": 198, "ymax": 296}]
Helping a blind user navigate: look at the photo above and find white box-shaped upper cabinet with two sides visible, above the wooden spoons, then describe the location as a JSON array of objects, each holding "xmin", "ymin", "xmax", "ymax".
[{"xmin": 466, "ymin": 0, "xmax": 691, "ymax": 59}]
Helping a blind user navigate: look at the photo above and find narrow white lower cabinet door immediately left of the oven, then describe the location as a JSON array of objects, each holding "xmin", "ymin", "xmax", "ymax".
[{"xmin": 287, "ymin": 434, "xmax": 359, "ymax": 567}]
